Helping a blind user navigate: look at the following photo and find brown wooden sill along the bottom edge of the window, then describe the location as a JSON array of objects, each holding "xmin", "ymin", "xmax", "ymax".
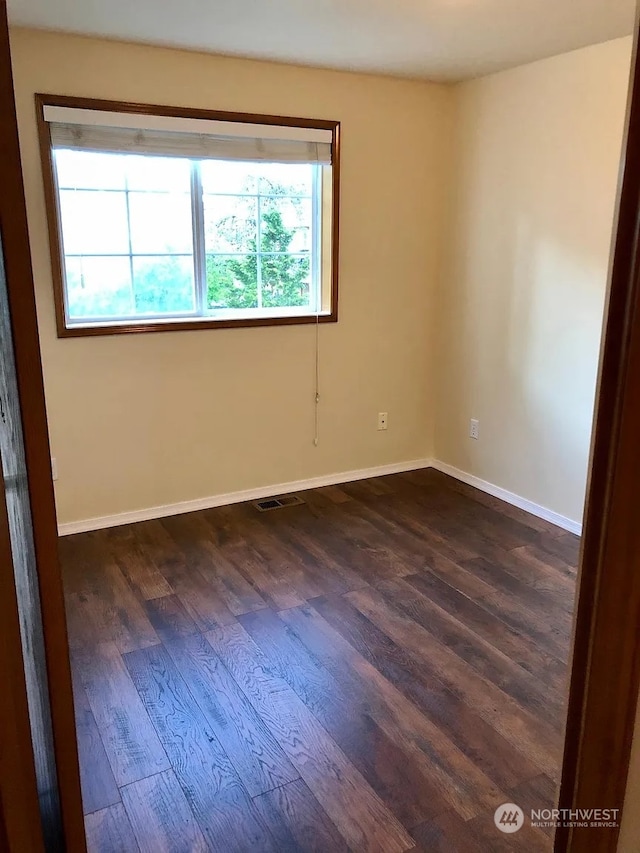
[{"xmin": 58, "ymin": 310, "xmax": 338, "ymax": 338}]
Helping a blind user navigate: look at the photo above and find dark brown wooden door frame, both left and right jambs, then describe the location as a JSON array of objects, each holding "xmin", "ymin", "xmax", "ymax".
[{"xmin": 5, "ymin": 0, "xmax": 640, "ymax": 853}]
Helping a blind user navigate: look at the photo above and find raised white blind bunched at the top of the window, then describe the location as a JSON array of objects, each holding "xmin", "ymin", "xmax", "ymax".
[{"xmin": 44, "ymin": 106, "xmax": 332, "ymax": 165}]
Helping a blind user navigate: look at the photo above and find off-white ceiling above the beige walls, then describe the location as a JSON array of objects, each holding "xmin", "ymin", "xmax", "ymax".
[{"xmin": 9, "ymin": 0, "xmax": 635, "ymax": 80}]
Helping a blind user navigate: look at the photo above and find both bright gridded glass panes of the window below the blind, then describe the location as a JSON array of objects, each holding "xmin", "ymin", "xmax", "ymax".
[{"xmin": 54, "ymin": 141, "xmax": 327, "ymax": 325}]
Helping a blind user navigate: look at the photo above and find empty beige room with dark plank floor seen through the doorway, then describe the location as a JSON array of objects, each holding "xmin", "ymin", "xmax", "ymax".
[{"xmin": 0, "ymin": 0, "xmax": 635, "ymax": 853}]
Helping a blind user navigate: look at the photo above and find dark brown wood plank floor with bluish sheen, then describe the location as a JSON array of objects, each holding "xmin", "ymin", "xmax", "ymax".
[{"xmin": 60, "ymin": 470, "xmax": 578, "ymax": 853}]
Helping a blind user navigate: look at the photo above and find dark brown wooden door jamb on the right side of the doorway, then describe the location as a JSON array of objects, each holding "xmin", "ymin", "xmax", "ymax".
[{"xmin": 555, "ymin": 8, "xmax": 640, "ymax": 853}]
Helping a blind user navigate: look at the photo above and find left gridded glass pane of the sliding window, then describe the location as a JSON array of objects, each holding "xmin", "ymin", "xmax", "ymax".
[{"xmin": 55, "ymin": 149, "xmax": 196, "ymax": 320}]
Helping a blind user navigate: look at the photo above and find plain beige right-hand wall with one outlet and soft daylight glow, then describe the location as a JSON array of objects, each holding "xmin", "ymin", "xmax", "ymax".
[{"xmin": 435, "ymin": 38, "xmax": 631, "ymax": 520}]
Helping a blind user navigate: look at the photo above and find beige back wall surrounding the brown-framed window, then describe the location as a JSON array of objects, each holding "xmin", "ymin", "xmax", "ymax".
[{"xmin": 7, "ymin": 30, "xmax": 450, "ymax": 522}]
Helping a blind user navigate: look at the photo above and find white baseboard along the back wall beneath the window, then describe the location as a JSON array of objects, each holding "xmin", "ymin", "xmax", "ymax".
[{"xmin": 58, "ymin": 459, "xmax": 432, "ymax": 536}]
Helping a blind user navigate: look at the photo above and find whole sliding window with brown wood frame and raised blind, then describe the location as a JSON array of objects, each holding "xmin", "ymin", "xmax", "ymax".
[{"xmin": 38, "ymin": 96, "xmax": 338, "ymax": 336}]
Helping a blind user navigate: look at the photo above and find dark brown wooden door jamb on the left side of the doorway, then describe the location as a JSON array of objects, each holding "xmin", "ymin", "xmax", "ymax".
[{"xmin": 0, "ymin": 0, "xmax": 86, "ymax": 853}]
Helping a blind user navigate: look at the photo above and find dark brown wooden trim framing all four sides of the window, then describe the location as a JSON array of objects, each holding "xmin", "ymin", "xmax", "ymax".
[{"xmin": 35, "ymin": 94, "xmax": 340, "ymax": 338}]
